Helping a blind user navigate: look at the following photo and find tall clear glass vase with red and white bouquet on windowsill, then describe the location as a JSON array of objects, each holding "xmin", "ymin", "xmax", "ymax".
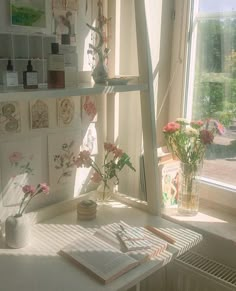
[{"xmin": 163, "ymin": 118, "xmax": 222, "ymax": 215}]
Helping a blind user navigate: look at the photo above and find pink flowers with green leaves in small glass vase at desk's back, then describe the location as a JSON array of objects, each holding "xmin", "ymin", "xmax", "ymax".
[{"xmin": 75, "ymin": 142, "xmax": 136, "ymax": 201}]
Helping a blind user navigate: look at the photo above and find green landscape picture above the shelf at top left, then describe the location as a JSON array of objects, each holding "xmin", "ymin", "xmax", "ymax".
[{"xmin": 10, "ymin": 0, "xmax": 46, "ymax": 28}]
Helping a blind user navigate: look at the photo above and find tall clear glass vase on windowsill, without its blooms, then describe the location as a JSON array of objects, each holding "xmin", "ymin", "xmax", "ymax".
[{"xmin": 178, "ymin": 162, "xmax": 202, "ymax": 216}]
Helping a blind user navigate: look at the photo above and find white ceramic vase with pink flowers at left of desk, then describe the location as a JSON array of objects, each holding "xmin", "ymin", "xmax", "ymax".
[{"xmin": 5, "ymin": 183, "xmax": 49, "ymax": 248}]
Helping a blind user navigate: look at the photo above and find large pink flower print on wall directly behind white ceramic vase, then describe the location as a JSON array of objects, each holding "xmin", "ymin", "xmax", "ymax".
[{"xmin": 0, "ymin": 137, "xmax": 42, "ymax": 206}]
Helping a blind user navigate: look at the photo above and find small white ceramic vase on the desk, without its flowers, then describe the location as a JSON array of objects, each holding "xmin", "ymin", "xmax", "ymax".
[{"xmin": 5, "ymin": 215, "xmax": 30, "ymax": 249}]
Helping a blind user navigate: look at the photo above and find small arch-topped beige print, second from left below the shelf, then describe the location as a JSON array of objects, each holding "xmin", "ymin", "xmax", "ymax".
[{"xmin": 30, "ymin": 100, "xmax": 49, "ymax": 129}]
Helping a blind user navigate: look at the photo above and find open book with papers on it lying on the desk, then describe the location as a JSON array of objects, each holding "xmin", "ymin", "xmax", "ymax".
[{"xmin": 59, "ymin": 222, "xmax": 170, "ymax": 284}]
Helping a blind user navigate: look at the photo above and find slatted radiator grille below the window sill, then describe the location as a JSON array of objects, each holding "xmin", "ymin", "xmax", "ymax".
[{"xmin": 176, "ymin": 251, "xmax": 236, "ymax": 291}]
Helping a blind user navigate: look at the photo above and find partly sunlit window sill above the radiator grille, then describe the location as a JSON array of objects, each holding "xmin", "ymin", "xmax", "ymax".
[{"xmin": 162, "ymin": 201, "xmax": 236, "ymax": 268}]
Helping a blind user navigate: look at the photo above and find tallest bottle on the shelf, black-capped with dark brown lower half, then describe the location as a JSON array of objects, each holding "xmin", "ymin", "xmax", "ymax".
[{"xmin": 48, "ymin": 43, "xmax": 65, "ymax": 88}]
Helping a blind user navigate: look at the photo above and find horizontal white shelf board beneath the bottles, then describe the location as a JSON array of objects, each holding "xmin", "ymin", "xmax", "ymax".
[{"xmin": 0, "ymin": 83, "xmax": 148, "ymax": 101}]
